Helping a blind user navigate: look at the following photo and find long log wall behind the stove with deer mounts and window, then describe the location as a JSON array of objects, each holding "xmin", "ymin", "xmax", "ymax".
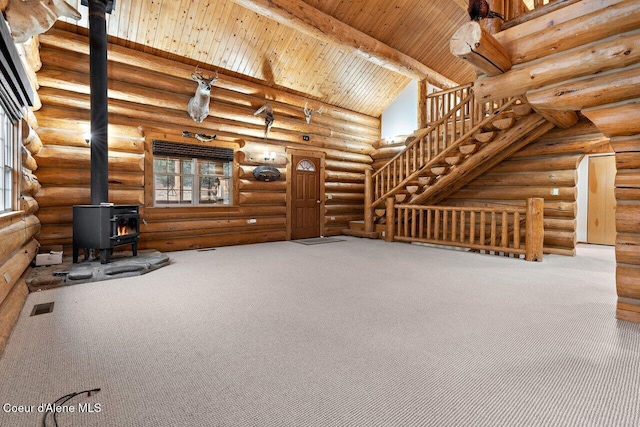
[{"xmin": 34, "ymin": 29, "xmax": 380, "ymax": 251}]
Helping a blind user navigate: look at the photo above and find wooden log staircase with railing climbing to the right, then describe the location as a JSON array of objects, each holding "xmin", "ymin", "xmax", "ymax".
[{"xmin": 343, "ymin": 83, "xmax": 554, "ymax": 238}]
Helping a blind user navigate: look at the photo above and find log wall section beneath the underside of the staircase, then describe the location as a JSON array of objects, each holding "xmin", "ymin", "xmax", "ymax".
[{"xmin": 441, "ymin": 120, "xmax": 611, "ymax": 255}]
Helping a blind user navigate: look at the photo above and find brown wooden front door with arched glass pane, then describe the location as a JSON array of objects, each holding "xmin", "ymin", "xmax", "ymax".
[{"xmin": 291, "ymin": 155, "xmax": 321, "ymax": 239}]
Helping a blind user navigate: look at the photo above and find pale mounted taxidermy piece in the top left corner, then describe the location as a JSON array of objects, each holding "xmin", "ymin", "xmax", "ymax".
[{"xmin": 0, "ymin": 0, "xmax": 82, "ymax": 43}]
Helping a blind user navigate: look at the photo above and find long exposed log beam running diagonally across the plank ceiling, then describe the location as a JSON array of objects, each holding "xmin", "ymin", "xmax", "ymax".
[{"xmin": 232, "ymin": 0, "xmax": 458, "ymax": 88}]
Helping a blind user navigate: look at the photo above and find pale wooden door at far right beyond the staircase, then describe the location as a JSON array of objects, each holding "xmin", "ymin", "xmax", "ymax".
[{"xmin": 587, "ymin": 155, "xmax": 616, "ymax": 245}]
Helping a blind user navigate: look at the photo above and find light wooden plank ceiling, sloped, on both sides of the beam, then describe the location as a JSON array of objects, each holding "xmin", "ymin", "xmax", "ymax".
[{"xmin": 58, "ymin": 0, "xmax": 475, "ymax": 117}]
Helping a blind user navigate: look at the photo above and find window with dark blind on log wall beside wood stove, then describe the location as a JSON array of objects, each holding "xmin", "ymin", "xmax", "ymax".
[{"xmin": 153, "ymin": 140, "xmax": 234, "ymax": 207}]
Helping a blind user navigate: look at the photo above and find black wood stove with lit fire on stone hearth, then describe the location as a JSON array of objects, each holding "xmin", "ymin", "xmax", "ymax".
[{"xmin": 73, "ymin": 203, "xmax": 140, "ymax": 264}]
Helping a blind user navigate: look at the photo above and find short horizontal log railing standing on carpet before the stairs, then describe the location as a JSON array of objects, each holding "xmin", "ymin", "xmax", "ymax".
[{"xmin": 385, "ymin": 197, "xmax": 544, "ymax": 261}]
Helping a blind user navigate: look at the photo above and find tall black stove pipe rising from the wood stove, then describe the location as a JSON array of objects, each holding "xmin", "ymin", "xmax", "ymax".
[{"xmin": 88, "ymin": 0, "xmax": 109, "ymax": 205}]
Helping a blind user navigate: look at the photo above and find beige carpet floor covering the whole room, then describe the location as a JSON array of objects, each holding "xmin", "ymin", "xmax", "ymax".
[{"xmin": 0, "ymin": 237, "xmax": 640, "ymax": 427}]
